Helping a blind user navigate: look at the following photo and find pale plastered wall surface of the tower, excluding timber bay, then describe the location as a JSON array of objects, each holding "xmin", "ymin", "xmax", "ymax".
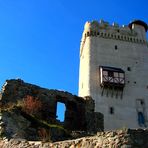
[{"xmin": 79, "ymin": 20, "xmax": 148, "ymax": 129}]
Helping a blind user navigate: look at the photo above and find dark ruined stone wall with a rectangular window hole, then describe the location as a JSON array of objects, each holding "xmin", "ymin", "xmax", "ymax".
[{"xmin": 0, "ymin": 79, "xmax": 103, "ymax": 141}]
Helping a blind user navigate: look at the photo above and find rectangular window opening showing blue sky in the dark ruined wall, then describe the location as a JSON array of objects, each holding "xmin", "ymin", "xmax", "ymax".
[{"xmin": 56, "ymin": 102, "xmax": 66, "ymax": 122}]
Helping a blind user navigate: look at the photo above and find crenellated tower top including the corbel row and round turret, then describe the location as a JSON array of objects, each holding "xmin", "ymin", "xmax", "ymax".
[{"xmin": 81, "ymin": 20, "xmax": 148, "ymax": 56}]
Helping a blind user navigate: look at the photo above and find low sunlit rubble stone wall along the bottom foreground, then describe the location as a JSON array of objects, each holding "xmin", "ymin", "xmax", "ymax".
[{"xmin": 0, "ymin": 129, "xmax": 148, "ymax": 148}]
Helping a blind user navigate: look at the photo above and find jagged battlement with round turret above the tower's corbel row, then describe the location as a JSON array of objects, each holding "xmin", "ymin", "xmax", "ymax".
[{"xmin": 84, "ymin": 20, "xmax": 148, "ymax": 36}]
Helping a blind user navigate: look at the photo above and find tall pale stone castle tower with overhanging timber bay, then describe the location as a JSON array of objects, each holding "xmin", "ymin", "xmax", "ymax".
[{"xmin": 79, "ymin": 20, "xmax": 148, "ymax": 130}]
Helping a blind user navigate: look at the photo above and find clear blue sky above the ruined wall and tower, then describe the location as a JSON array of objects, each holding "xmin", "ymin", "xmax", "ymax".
[{"xmin": 0, "ymin": 0, "xmax": 148, "ymax": 120}]
